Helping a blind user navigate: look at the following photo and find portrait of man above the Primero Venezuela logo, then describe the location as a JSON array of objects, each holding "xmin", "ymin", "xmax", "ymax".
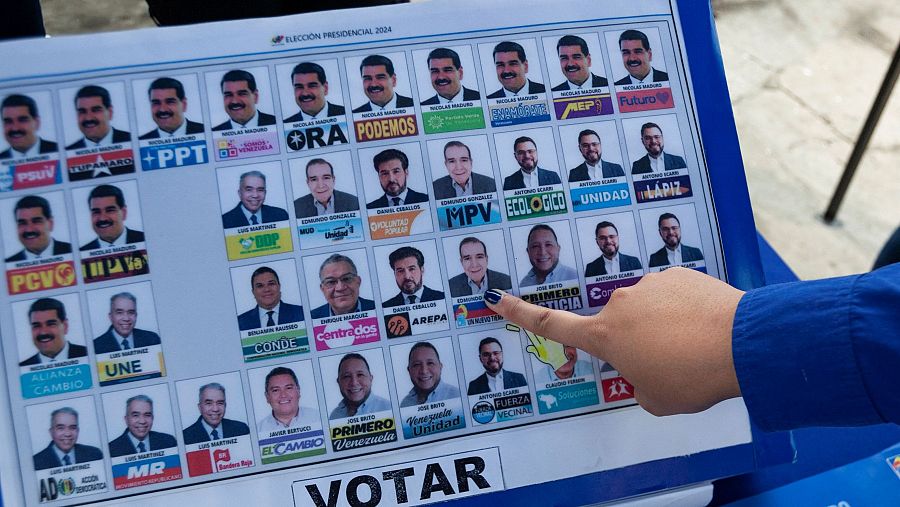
[{"xmin": 328, "ymin": 352, "xmax": 391, "ymax": 419}]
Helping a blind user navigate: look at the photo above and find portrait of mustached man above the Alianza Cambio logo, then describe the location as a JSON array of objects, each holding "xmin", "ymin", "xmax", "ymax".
[{"xmin": 19, "ymin": 298, "xmax": 87, "ymax": 366}]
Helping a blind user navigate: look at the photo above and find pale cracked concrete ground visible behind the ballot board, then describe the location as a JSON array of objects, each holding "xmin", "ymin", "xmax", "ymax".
[{"xmin": 42, "ymin": 0, "xmax": 900, "ymax": 279}]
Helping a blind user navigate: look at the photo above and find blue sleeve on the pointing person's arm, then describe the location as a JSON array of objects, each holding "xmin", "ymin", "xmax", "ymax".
[{"xmin": 732, "ymin": 264, "xmax": 900, "ymax": 431}]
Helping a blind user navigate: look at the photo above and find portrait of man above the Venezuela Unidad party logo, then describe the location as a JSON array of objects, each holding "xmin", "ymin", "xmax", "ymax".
[{"xmin": 400, "ymin": 342, "xmax": 459, "ymax": 408}]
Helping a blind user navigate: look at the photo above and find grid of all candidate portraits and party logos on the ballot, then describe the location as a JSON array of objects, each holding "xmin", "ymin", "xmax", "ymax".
[{"xmin": 0, "ymin": 22, "xmax": 718, "ymax": 500}]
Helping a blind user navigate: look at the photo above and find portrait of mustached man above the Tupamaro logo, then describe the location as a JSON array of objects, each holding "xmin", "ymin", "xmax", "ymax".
[{"xmin": 66, "ymin": 85, "xmax": 131, "ymax": 150}]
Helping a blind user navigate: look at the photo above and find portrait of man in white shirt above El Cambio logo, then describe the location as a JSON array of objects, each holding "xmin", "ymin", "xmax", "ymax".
[{"xmin": 256, "ymin": 366, "xmax": 320, "ymax": 436}]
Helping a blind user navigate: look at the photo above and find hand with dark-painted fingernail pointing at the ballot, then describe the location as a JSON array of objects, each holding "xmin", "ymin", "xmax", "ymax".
[{"xmin": 485, "ymin": 267, "xmax": 743, "ymax": 415}]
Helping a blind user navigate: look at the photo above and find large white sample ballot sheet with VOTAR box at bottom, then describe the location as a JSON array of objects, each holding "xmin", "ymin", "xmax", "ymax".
[{"xmin": 0, "ymin": 0, "xmax": 753, "ymax": 506}]
